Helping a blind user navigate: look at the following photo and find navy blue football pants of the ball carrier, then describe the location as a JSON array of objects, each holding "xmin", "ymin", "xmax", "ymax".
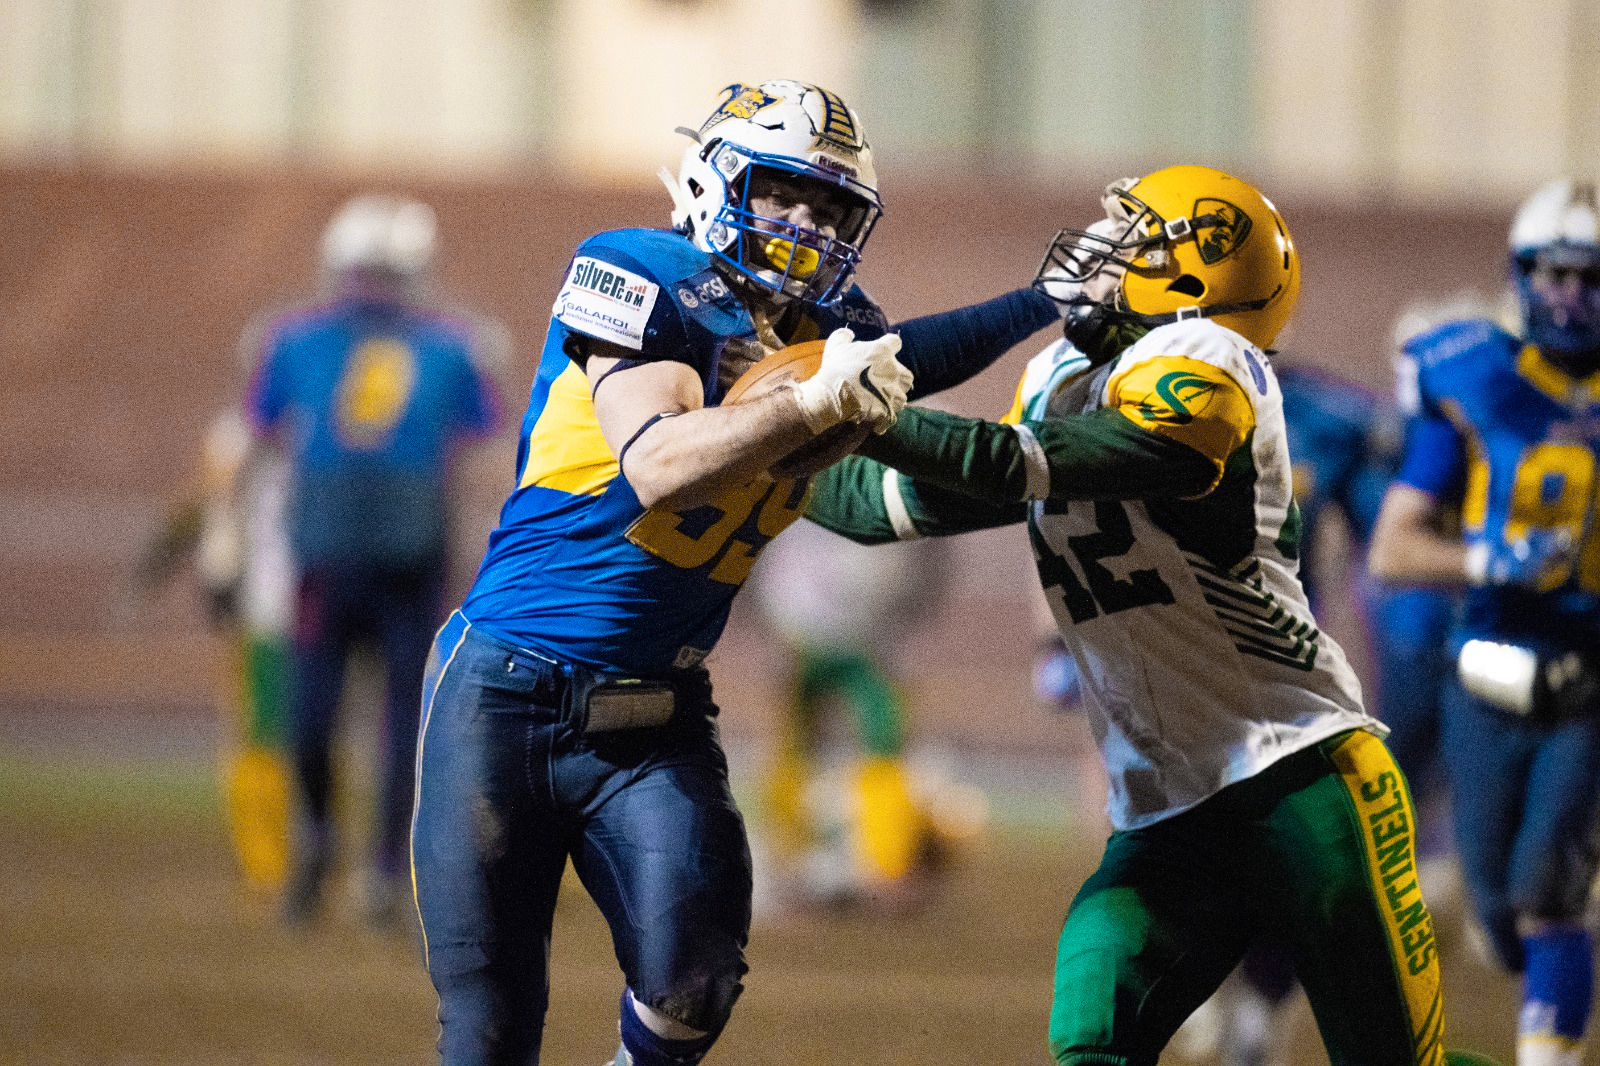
[{"xmin": 411, "ymin": 613, "xmax": 750, "ymax": 1066}]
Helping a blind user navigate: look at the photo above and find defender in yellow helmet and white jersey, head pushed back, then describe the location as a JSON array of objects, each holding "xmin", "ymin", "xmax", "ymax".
[{"xmin": 808, "ymin": 166, "xmax": 1478, "ymax": 1066}]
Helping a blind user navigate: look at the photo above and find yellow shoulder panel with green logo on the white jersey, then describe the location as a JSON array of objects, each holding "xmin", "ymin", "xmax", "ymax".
[{"xmin": 1106, "ymin": 355, "xmax": 1256, "ymax": 477}]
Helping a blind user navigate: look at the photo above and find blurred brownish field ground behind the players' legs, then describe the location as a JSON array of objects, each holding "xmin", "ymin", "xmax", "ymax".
[{"xmin": 0, "ymin": 697, "xmax": 1548, "ymax": 1066}]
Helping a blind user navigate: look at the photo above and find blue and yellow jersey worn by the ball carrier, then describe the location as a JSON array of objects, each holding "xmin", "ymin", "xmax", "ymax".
[{"xmin": 461, "ymin": 229, "xmax": 888, "ymax": 675}]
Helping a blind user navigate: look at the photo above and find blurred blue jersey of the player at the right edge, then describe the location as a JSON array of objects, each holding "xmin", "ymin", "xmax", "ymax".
[{"xmin": 1398, "ymin": 320, "xmax": 1600, "ymax": 648}]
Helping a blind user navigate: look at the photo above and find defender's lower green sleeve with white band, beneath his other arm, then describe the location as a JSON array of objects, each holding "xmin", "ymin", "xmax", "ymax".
[{"xmin": 805, "ymin": 455, "xmax": 1027, "ymax": 544}]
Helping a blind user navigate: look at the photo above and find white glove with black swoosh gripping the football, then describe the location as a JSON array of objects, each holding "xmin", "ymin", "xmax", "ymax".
[{"xmin": 789, "ymin": 328, "xmax": 912, "ymax": 434}]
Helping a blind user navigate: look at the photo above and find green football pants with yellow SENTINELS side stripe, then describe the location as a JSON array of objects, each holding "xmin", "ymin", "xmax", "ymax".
[{"xmin": 1050, "ymin": 731, "xmax": 1443, "ymax": 1066}]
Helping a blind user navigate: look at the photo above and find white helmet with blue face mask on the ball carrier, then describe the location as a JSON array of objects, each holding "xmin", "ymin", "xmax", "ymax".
[{"xmin": 661, "ymin": 80, "xmax": 883, "ymax": 304}]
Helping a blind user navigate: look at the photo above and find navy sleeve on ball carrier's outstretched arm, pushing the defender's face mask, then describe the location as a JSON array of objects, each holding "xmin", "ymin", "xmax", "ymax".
[{"xmin": 894, "ymin": 288, "xmax": 1061, "ymax": 400}]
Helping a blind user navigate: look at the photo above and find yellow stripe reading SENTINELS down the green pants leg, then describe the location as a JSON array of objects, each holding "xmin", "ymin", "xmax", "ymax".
[{"xmin": 1331, "ymin": 731, "xmax": 1445, "ymax": 1066}]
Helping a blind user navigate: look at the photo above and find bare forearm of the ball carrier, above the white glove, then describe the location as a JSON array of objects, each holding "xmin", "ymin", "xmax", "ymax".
[{"xmin": 622, "ymin": 389, "xmax": 813, "ymax": 511}]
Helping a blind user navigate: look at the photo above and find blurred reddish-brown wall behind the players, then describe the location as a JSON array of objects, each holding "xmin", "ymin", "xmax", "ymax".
[{"xmin": 0, "ymin": 168, "xmax": 1509, "ymax": 744}]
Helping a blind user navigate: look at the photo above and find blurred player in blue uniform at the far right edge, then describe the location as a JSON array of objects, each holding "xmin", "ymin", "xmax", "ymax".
[{"xmin": 1371, "ymin": 181, "xmax": 1600, "ymax": 1066}]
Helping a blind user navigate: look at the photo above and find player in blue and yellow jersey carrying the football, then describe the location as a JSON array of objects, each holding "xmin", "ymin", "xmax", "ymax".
[{"xmin": 411, "ymin": 82, "xmax": 1059, "ymax": 1066}]
